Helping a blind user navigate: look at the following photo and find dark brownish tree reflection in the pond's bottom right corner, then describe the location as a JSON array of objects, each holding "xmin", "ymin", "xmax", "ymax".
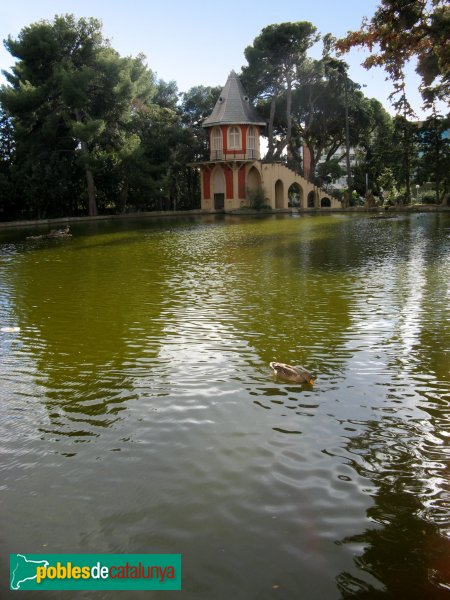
[{"xmin": 337, "ymin": 419, "xmax": 450, "ymax": 600}]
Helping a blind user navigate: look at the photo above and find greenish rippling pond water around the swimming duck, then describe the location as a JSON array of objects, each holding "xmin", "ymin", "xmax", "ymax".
[{"xmin": 0, "ymin": 213, "xmax": 450, "ymax": 600}]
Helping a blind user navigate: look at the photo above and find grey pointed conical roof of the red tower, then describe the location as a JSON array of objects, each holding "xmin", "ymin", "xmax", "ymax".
[{"xmin": 203, "ymin": 71, "xmax": 266, "ymax": 127}]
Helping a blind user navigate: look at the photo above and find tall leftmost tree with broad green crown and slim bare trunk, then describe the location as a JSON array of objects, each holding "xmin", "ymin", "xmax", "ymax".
[{"xmin": 0, "ymin": 15, "xmax": 151, "ymax": 215}]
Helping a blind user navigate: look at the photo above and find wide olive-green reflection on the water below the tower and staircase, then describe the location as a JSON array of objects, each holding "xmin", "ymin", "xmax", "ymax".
[{"xmin": 178, "ymin": 215, "xmax": 446, "ymax": 384}]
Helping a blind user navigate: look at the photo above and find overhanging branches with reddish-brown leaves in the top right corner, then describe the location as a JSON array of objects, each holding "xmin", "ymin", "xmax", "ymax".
[{"xmin": 337, "ymin": 0, "xmax": 450, "ymax": 108}]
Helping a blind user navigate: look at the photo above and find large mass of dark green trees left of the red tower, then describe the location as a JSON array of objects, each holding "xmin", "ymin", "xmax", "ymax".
[{"xmin": 0, "ymin": 15, "xmax": 198, "ymax": 217}]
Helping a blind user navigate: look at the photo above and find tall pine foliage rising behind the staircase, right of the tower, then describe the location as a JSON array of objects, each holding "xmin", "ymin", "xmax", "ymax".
[{"xmin": 243, "ymin": 29, "xmax": 379, "ymax": 193}]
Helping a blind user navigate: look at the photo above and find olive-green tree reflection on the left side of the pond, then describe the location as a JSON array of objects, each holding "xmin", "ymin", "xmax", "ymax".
[{"xmin": 11, "ymin": 231, "xmax": 171, "ymax": 439}]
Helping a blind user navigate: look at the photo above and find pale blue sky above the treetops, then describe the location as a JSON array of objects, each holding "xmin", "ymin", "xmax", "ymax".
[{"xmin": 0, "ymin": 0, "xmax": 432, "ymax": 117}]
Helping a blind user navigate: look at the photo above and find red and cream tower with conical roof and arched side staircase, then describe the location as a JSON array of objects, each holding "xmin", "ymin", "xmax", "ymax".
[{"xmin": 192, "ymin": 71, "xmax": 341, "ymax": 211}]
